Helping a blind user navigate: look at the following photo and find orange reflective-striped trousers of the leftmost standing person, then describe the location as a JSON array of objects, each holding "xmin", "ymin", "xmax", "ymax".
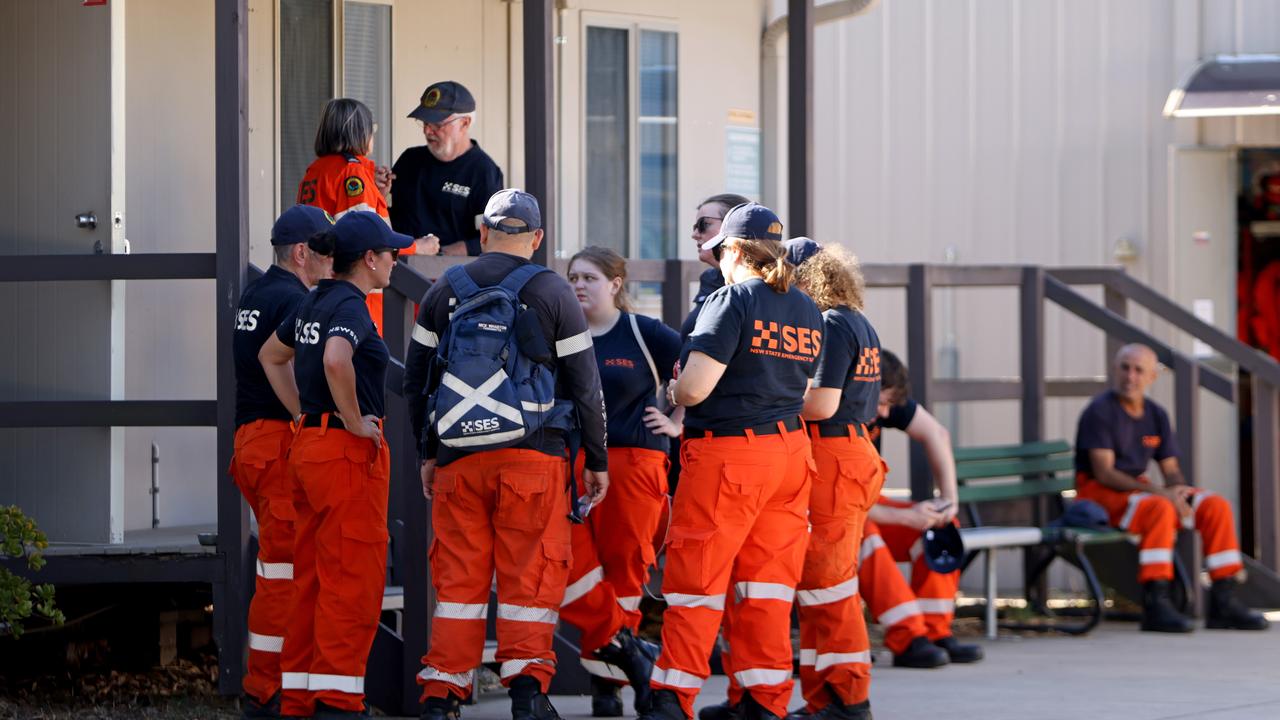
[{"xmin": 230, "ymin": 420, "xmax": 297, "ymax": 703}]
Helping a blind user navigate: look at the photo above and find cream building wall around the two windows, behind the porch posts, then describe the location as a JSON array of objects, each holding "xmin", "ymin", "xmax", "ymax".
[{"xmin": 102, "ymin": 0, "xmax": 763, "ymax": 530}]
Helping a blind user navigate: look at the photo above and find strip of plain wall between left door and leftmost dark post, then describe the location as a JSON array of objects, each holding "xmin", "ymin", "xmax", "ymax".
[{"xmin": 124, "ymin": 0, "xmax": 217, "ymax": 530}]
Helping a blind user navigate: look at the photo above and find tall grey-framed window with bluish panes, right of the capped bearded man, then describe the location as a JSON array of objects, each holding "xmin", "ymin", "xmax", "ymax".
[{"xmin": 584, "ymin": 27, "xmax": 678, "ymax": 259}]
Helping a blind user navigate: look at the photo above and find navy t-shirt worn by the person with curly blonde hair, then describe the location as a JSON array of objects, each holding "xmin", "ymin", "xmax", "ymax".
[{"xmin": 813, "ymin": 307, "xmax": 879, "ymax": 425}]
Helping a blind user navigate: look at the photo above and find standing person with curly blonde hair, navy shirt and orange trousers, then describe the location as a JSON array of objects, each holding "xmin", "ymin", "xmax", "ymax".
[{"xmin": 785, "ymin": 237, "xmax": 887, "ymax": 720}]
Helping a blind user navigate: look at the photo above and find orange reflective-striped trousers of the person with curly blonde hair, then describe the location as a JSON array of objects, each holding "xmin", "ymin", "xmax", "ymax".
[{"xmin": 796, "ymin": 425, "xmax": 887, "ymax": 712}]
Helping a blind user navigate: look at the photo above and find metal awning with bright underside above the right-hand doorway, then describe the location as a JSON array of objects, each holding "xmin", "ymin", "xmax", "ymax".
[{"xmin": 1165, "ymin": 55, "xmax": 1280, "ymax": 118}]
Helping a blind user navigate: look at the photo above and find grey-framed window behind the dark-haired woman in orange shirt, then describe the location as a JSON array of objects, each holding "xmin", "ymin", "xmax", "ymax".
[{"xmin": 279, "ymin": 0, "xmax": 393, "ymax": 208}]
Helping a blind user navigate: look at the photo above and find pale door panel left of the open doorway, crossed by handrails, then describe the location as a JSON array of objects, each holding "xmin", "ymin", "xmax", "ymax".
[{"xmin": 1169, "ymin": 147, "xmax": 1239, "ymax": 507}]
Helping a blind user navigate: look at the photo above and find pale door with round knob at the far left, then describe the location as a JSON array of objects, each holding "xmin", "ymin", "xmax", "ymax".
[{"xmin": 0, "ymin": 0, "xmax": 124, "ymax": 542}]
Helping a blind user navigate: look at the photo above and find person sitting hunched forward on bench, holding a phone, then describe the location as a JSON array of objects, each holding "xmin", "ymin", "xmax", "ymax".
[{"xmin": 858, "ymin": 350, "xmax": 982, "ymax": 669}]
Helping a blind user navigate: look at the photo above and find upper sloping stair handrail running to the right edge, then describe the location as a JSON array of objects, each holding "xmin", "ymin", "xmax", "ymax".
[{"xmin": 1047, "ymin": 268, "xmax": 1280, "ymax": 386}]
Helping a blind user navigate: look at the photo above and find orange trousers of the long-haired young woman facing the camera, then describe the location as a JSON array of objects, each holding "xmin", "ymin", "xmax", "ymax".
[{"xmin": 561, "ymin": 447, "xmax": 668, "ymax": 683}]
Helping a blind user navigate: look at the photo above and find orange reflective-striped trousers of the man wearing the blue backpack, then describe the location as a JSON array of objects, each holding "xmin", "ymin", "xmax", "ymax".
[{"xmin": 417, "ymin": 448, "xmax": 572, "ymax": 701}]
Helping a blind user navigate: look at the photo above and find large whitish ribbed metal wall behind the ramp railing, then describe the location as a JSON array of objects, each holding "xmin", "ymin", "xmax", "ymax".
[{"xmin": 808, "ymin": 0, "xmax": 1280, "ymax": 509}]
